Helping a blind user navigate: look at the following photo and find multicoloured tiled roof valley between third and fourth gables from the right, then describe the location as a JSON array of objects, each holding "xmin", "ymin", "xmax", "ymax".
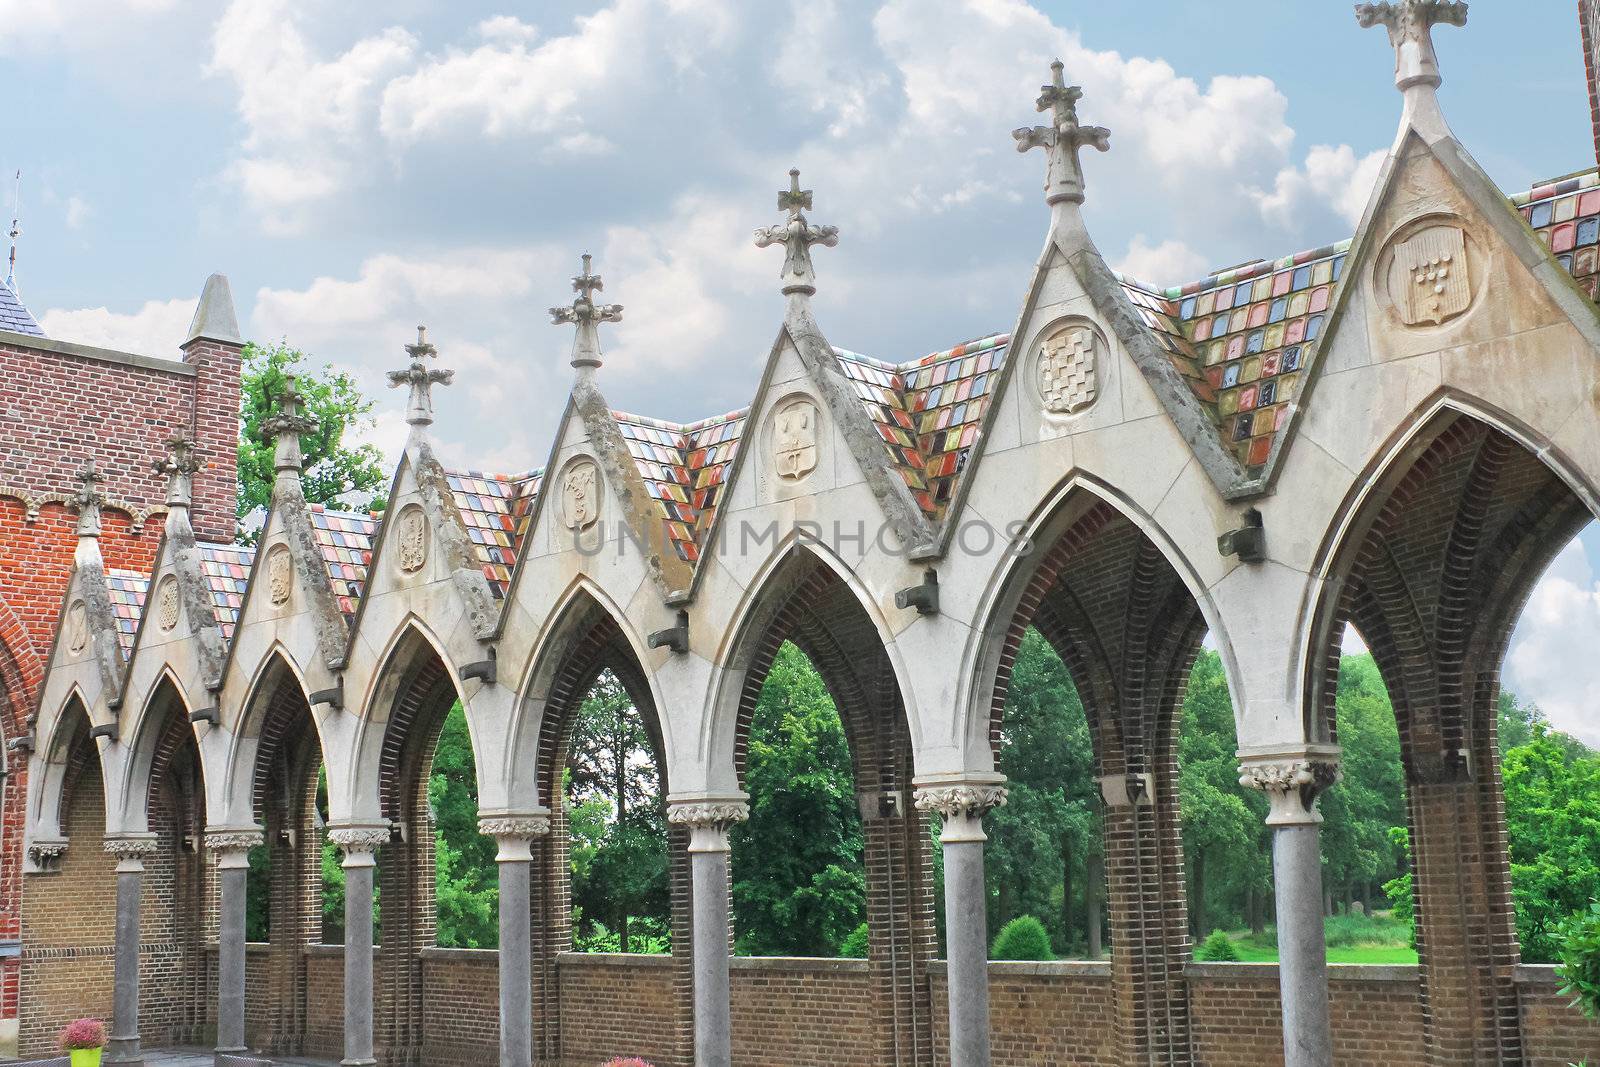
[{"xmin": 611, "ymin": 410, "xmax": 749, "ymax": 563}]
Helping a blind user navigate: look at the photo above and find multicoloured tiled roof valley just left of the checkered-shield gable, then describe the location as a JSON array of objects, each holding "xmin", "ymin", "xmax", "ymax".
[{"xmin": 834, "ymin": 333, "xmax": 1011, "ymax": 518}]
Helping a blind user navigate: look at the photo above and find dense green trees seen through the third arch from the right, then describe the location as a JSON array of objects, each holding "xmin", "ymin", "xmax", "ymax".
[{"xmin": 731, "ymin": 641, "xmax": 867, "ymax": 957}]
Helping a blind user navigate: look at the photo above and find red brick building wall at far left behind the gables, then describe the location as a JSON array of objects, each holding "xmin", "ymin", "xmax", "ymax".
[{"xmin": 0, "ymin": 331, "xmax": 240, "ymax": 1036}]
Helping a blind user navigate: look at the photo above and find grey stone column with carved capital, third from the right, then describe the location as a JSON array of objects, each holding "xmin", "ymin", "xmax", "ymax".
[{"xmin": 667, "ymin": 800, "xmax": 750, "ymax": 1067}]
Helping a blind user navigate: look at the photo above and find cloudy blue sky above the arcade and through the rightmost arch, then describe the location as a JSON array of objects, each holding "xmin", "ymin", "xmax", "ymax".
[{"xmin": 0, "ymin": 0, "xmax": 1600, "ymax": 744}]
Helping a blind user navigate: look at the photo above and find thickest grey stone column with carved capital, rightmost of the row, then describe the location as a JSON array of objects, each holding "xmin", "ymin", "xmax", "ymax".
[{"xmin": 1238, "ymin": 745, "xmax": 1339, "ymax": 1067}]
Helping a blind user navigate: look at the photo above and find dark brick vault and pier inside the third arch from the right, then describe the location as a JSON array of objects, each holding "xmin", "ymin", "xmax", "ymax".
[{"xmin": 730, "ymin": 547, "xmax": 938, "ymax": 1065}]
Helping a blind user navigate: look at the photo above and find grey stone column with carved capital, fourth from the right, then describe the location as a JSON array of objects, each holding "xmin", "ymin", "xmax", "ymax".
[{"xmin": 478, "ymin": 811, "xmax": 550, "ymax": 1067}]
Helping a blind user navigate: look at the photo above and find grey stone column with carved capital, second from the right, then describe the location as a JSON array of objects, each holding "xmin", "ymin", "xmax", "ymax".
[{"xmin": 917, "ymin": 782, "xmax": 1005, "ymax": 1067}]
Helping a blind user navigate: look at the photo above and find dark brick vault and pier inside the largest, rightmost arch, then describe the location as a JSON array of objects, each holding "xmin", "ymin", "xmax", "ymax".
[{"xmin": 1306, "ymin": 410, "xmax": 1594, "ymax": 1064}]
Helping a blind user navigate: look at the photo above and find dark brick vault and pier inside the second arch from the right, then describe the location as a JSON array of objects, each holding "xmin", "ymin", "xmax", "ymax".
[{"xmin": 989, "ymin": 493, "xmax": 1206, "ymax": 1064}]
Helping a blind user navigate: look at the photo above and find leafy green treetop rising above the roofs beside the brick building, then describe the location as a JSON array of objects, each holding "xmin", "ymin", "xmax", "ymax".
[{"xmin": 238, "ymin": 341, "xmax": 387, "ymax": 520}]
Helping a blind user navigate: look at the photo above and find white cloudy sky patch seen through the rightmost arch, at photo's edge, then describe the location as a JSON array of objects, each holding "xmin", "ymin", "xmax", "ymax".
[{"xmin": 1506, "ymin": 526, "xmax": 1600, "ymax": 745}]
